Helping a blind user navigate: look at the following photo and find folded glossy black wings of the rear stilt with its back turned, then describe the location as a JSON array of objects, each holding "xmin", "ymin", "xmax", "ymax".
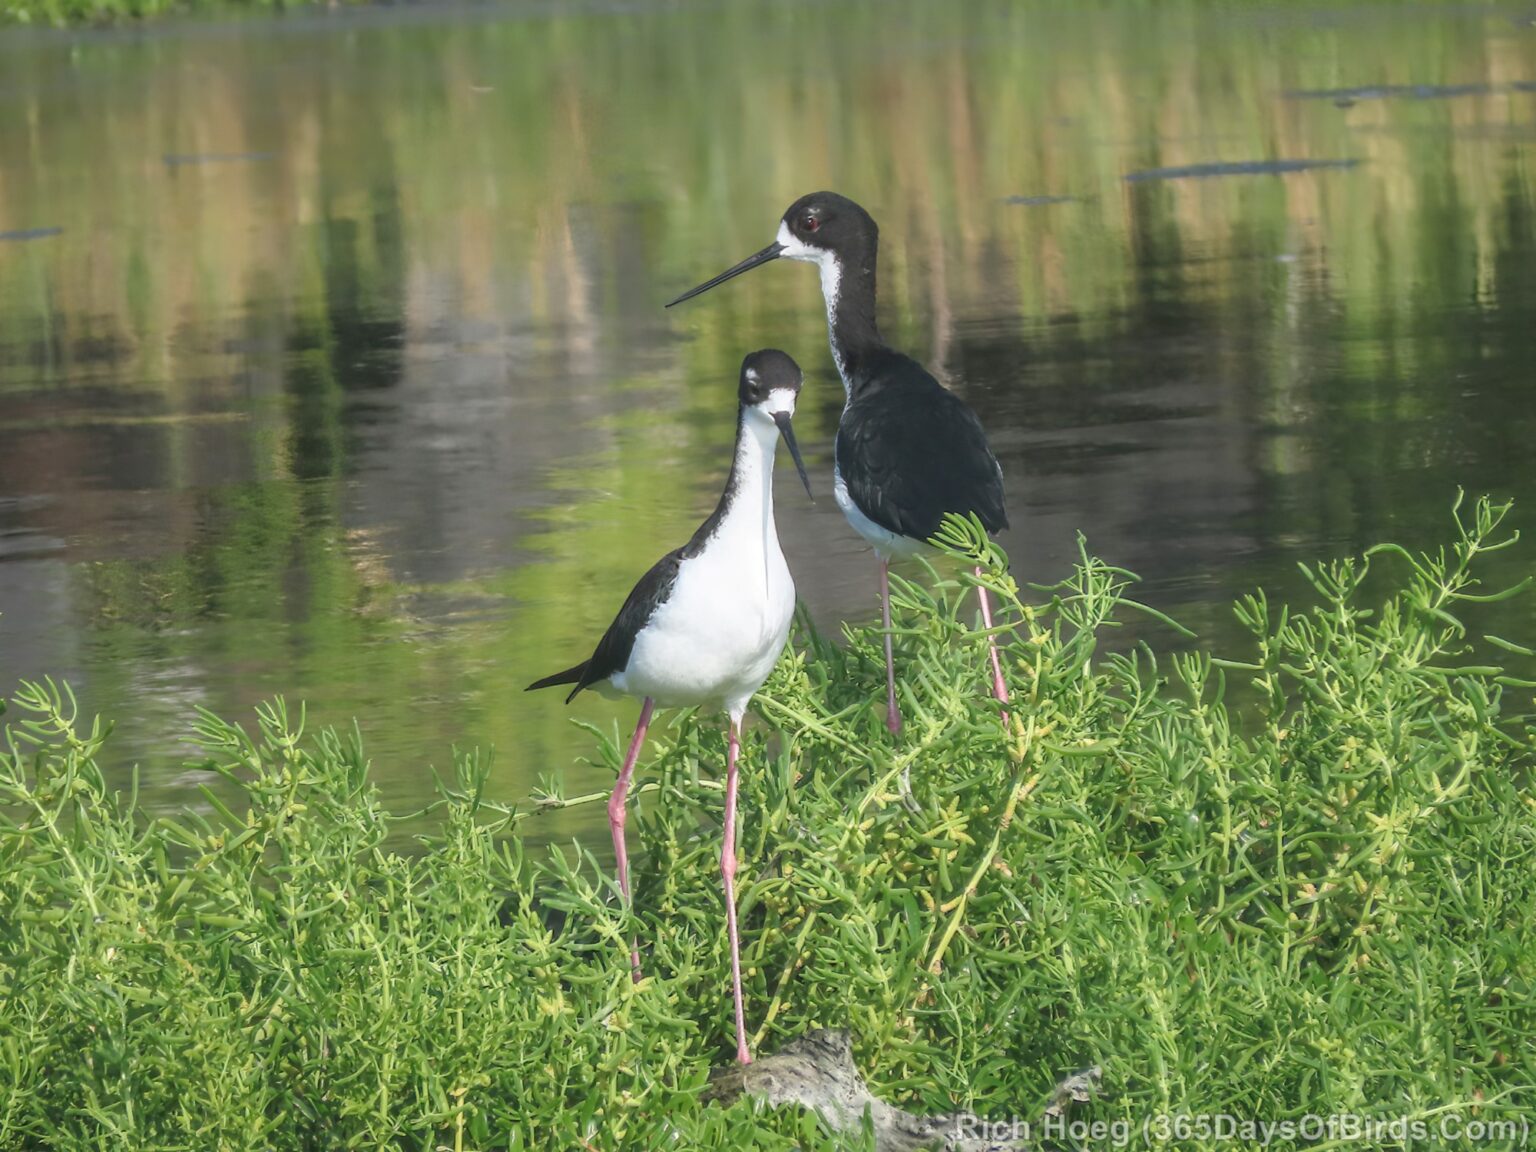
[{"xmin": 836, "ymin": 356, "xmax": 1008, "ymax": 541}]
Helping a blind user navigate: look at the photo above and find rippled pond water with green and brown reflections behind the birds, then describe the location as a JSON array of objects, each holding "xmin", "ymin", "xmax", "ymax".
[{"xmin": 0, "ymin": 0, "xmax": 1536, "ymax": 840}]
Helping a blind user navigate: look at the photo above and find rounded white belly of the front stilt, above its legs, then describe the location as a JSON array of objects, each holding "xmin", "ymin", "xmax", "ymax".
[{"xmin": 613, "ymin": 541, "xmax": 794, "ymax": 713}]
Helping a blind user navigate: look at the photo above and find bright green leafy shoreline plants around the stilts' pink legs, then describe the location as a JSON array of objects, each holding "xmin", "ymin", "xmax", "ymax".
[{"xmin": 0, "ymin": 501, "xmax": 1536, "ymax": 1149}]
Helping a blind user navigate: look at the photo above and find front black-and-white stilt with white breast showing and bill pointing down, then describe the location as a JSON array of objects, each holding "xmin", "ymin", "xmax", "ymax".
[{"xmin": 527, "ymin": 349, "xmax": 814, "ymax": 1064}]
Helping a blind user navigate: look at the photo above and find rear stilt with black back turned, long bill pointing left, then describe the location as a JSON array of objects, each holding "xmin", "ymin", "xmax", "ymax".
[{"xmin": 667, "ymin": 192, "xmax": 1008, "ymax": 734}]
